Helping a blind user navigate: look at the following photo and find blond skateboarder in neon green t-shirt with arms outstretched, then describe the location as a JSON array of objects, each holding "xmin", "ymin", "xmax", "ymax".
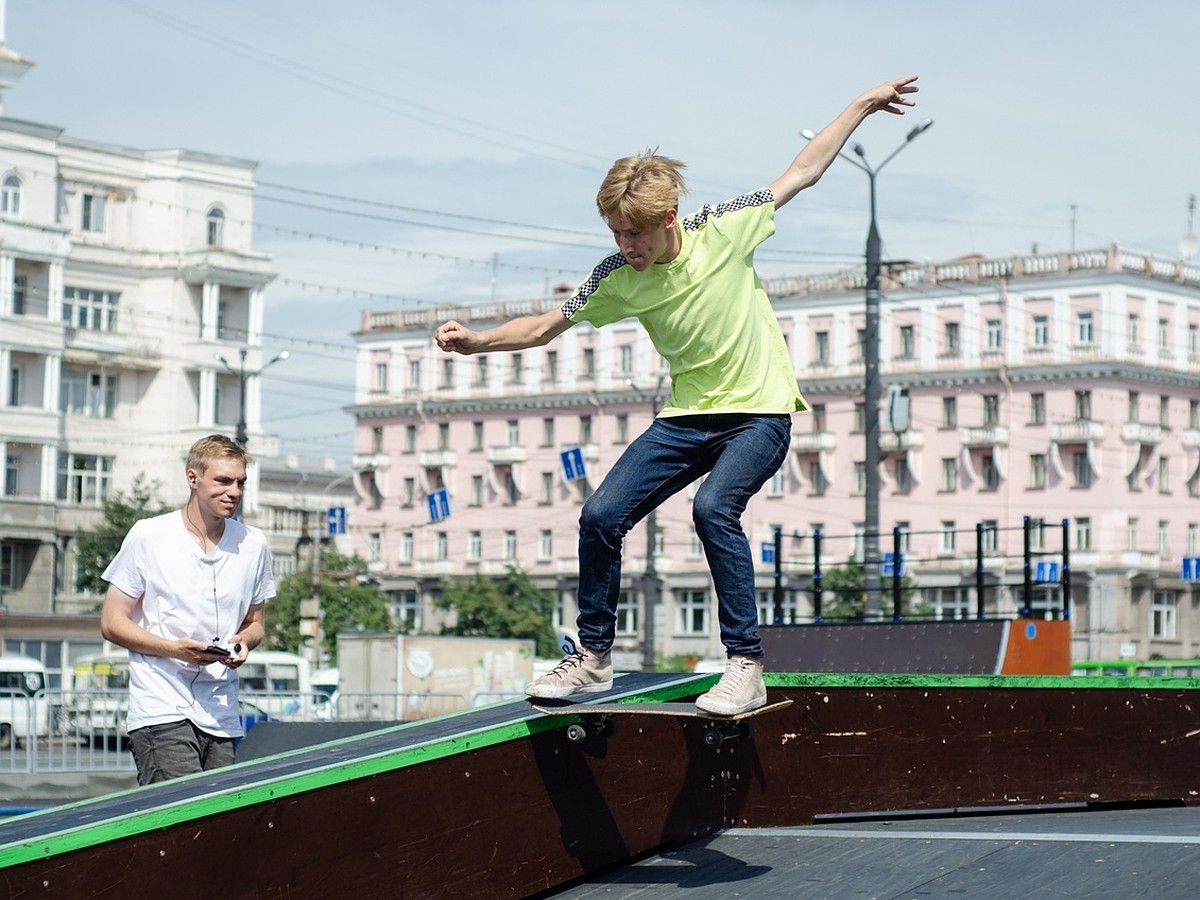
[{"xmin": 436, "ymin": 76, "xmax": 917, "ymax": 715}]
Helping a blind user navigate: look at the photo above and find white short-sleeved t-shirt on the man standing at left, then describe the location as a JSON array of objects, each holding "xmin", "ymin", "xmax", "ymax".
[{"xmin": 102, "ymin": 510, "xmax": 275, "ymax": 738}]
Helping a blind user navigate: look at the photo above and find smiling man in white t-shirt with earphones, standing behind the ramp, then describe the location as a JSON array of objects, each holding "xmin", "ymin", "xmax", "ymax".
[{"xmin": 100, "ymin": 434, "xmax": 275, "ymax": 785}]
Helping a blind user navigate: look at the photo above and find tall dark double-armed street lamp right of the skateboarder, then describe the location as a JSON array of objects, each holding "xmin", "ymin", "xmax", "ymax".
[{"xmin": 800, "ymin": 119, "xmax": 934, "ymax": 617}]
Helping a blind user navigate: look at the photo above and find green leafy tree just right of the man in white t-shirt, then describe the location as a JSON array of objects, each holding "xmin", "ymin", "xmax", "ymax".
[{"xmin": 264, "ymin": 550, "xmax": 395, "ymax": 664}]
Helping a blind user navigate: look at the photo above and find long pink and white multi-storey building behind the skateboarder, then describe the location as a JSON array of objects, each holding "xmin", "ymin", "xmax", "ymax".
[{"xmin": 350, "ymin": 247, "xmax": 1200, "ymax": 660}]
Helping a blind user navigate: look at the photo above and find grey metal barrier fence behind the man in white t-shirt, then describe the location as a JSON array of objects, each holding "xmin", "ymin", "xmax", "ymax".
[{"xmin": 0, "ymin": 690, "xmax": 523, "ymax": 775}]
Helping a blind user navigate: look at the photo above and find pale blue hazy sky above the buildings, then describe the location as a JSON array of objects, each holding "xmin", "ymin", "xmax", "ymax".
[{"xmin": 0, "ymin": 0, "xmax": 1200, "ymax": 461}]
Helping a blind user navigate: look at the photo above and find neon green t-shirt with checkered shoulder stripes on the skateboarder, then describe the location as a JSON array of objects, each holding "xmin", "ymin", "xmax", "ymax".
[{"xmin": 563, "ymin": 188, "xmax": 808, "ymax": 416}]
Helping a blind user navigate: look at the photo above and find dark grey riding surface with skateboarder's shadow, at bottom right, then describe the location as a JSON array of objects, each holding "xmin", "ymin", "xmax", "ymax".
[{"xmin": 547, "ymin": 808, "xmax": 1200, "ymax": 900}]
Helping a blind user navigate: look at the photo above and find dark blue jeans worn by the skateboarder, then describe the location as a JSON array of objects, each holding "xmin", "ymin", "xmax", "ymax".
[{"xmin": 577, "ymin": 414, "xmax": 792, "ymax": 659}]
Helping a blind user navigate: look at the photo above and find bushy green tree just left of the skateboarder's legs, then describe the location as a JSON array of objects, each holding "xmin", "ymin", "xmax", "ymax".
[{"xmin": 433, "ymin": 565, "xmax": 558, "ymax": 656}]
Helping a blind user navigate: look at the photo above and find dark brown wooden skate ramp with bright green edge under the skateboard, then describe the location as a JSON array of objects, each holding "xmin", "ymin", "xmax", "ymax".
[{"xmin": 0, "ymin": 674, "xmax": 1200, "ymax": 898}]
